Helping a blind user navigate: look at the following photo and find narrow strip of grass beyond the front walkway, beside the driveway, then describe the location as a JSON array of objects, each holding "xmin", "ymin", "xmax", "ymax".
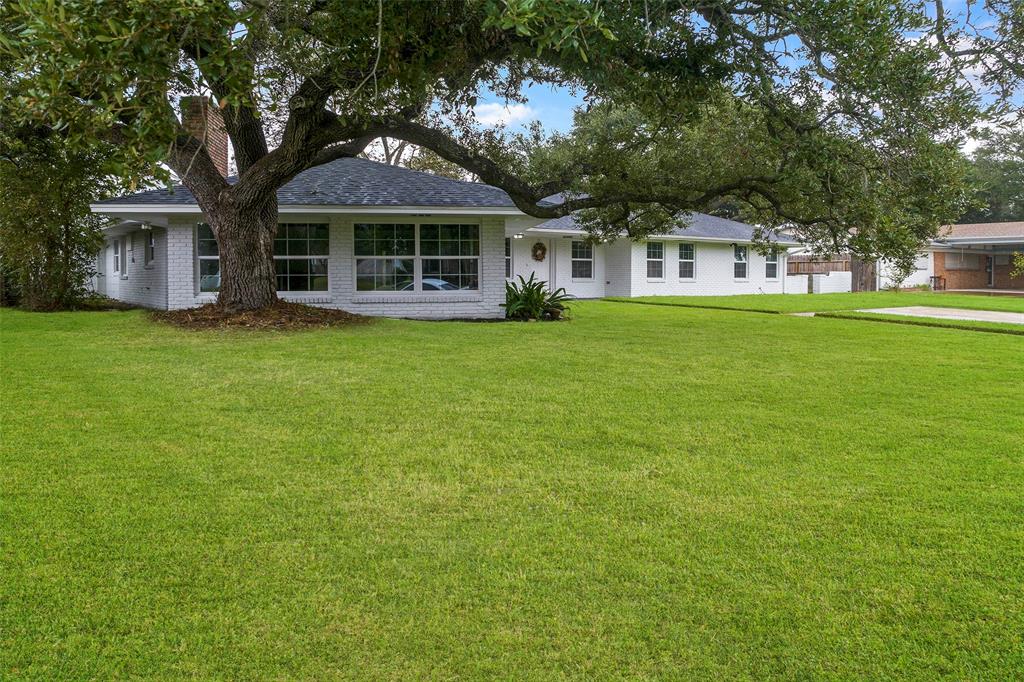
[{"xmin": 608, "ymin": 291, "xmax": 1024, "ymax": 312}]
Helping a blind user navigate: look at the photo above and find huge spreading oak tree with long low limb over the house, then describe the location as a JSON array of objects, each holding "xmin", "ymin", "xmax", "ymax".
[{"xmin": 0, "ymin": 0, "xmax": 974, "ymax": 308}]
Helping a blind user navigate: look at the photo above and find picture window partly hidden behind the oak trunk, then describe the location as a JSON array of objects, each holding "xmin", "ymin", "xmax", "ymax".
[{"xmin": 196, "ymin": 223, "xmax": 330, "ymax": 293}]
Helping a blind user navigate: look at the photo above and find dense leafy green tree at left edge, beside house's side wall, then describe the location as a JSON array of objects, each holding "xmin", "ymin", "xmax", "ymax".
[{"xmin": 0, "ymin": 134, "xmax": 134, "ymax": 310}]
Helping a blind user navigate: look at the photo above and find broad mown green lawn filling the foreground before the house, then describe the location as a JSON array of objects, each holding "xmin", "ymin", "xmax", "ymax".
[{"xmin": 6, "ymin": 303, "xmax": 1024, "ymax": 680}]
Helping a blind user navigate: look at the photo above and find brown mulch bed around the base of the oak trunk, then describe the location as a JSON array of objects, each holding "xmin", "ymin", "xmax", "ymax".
[{"xmin": 151, "ymin": 301, "xmax": 370, "ymax": 330}]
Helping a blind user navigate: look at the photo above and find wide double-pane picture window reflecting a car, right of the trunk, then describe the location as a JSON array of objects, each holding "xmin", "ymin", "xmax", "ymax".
[{"xmin": 354, "ymin": 223, "xmax": 480, "ymax": 292}]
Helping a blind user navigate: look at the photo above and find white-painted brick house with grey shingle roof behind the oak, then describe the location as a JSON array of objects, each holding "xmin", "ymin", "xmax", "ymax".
[{"xmin": 92, "ymin": 159, "xmax": 794, "ymax": 318}]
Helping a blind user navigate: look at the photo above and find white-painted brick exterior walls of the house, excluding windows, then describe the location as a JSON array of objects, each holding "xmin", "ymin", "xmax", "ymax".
[{"xmin": 104, "ymin": 213, "xmax": 806, "ymax": 319}]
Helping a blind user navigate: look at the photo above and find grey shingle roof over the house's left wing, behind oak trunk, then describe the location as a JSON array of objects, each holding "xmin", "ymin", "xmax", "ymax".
[{"xmin": 99, "ymin": 159, "xmax": 515, "ymax": 208}]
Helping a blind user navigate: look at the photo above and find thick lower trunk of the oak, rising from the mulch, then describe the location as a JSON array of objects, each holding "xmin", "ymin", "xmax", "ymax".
[{"xmin": 207, "ymin": 192, "xmax": 278, "ymax": 311}]
